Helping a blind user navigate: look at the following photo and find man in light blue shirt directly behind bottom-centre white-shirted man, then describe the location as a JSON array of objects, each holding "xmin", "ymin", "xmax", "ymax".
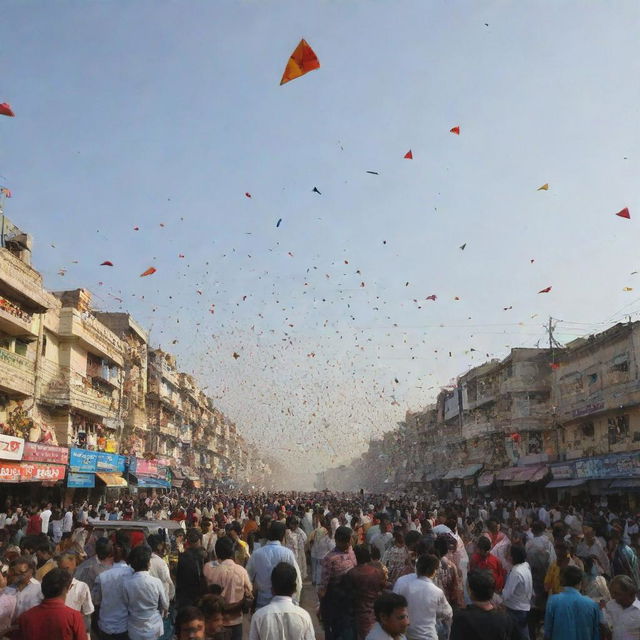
[{"xmin": 247, "ymin": 521, "xmax": 302, "ymax": 609}]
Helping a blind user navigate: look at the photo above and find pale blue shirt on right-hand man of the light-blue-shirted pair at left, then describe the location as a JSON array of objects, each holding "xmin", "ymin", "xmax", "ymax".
[{"xmin": 122, "ymin": 571, "xmax": 169, "ymax": 640}]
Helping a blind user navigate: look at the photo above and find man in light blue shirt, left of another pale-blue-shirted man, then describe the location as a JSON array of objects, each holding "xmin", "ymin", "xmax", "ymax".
[{"xmin": 91, "ymin": 542, "xmax": 133, "ymax": 640}]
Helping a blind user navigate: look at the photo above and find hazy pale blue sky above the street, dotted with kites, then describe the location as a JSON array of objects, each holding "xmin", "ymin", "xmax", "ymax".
[{"xmin": 0, "ymin": 0, "xmax": 640, "ymax": 478}]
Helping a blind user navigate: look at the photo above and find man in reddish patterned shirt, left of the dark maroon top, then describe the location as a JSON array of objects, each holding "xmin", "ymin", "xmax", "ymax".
[{"xmin": 318, "ymin": 526, "xmax": 357, "ymax": 640}]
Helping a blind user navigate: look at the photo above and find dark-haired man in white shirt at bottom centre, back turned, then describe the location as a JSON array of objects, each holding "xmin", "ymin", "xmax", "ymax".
[{"xmin": 249, "ymin": 562, "xmax": 316, "ymax": 640}]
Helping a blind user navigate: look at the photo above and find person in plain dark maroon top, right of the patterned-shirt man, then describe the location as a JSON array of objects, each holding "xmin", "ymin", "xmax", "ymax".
[{"xmin": 345, "ymin": 544, "xmax": 387, "ymax": 640}]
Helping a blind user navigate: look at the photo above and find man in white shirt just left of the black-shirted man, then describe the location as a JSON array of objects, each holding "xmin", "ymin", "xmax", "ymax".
[{"xmin": 394, "ymin": 554, "xmax": 453, "ymax": 640}]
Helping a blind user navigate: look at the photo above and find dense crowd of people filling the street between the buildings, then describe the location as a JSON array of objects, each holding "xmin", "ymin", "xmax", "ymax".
[{"xmin": 0, "ymin": 490, "xmax": 640, "ymax": 640}]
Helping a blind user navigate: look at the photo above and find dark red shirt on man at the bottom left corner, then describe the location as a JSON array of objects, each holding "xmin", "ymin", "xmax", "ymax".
[{"xmin": 18, "ymin": 598, "xmax": 87, "ymax": 640}]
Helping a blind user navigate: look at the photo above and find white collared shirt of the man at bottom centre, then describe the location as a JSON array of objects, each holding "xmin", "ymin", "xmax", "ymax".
[{"xmin": 249, "ymin": 596, "xmax": 316, "ymax": 640}]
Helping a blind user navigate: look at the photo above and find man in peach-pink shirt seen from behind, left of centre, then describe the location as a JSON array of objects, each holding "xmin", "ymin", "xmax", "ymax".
[{"xmin": 204, "ymin": 536, "xmax": 252, "ymax": 640}]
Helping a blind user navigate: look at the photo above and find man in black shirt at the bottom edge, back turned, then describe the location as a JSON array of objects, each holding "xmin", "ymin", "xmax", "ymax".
[{"xmin": 449, "ymin": 569, "xmax": 520, "ymax": 640}]
